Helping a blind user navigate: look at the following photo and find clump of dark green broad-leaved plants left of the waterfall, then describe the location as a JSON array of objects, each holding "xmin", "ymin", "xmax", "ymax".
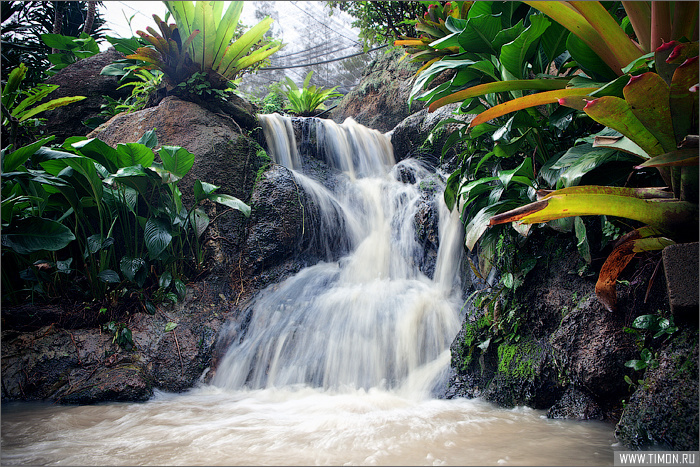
[{"xmin": 2, "ymin": 131, "xmax": 250, "ymax": 312}]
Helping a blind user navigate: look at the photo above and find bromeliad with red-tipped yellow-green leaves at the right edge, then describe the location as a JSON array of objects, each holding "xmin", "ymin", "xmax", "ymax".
[{"xmin": 491, "ymin": 43, "xmax": 699, "ymax": 310}]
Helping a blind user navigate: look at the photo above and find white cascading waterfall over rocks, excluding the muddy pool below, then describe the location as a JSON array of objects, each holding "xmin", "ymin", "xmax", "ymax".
[{"xmin": 212, "ymin": 114, "xmax": 462, "ymax": 393}]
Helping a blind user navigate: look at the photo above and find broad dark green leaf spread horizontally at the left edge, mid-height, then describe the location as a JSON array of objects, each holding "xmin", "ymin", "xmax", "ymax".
[{"xmin": 2, "ymin": 217, "xmax": 75, "ymax": 255}]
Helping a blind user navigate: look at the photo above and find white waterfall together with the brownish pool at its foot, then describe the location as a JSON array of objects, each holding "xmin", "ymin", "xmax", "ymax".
[{"xmin": 2, "ymin": 115, "xmax": 614, "ymax": 465}]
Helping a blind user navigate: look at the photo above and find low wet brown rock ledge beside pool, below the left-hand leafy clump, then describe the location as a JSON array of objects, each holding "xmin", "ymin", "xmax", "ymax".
[{"xmin": 2, "ymin": 281, "xmax": 230, "ymax": 404}]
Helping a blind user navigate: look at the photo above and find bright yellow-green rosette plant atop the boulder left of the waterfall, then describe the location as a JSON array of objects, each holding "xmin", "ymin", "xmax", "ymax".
[{"xmin": 127, "ymin": 1, "xmax": 281, "ymax": 91}]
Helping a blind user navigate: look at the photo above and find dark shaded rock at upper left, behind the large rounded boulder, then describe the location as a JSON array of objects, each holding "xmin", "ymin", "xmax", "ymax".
[{"xmin": 41, "ymin": 47, "xmax": 131, "ymax": 143}]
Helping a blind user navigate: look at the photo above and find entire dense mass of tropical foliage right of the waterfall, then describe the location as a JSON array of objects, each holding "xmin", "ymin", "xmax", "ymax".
[{"xmin": 396, "ymin": 2, "xmax": 698, "ymax": 309}]
